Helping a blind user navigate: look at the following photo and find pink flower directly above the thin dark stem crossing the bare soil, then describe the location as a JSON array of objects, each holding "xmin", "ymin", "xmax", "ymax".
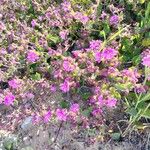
[{"xmin": 56, "ymin": 109, "xmax": 67, "ymax": 121}]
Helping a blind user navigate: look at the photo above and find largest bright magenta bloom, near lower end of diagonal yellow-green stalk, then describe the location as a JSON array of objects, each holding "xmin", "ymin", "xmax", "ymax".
[{"xmin": 101, "ymin": 47, "xmax": 117, "ymax": 60}]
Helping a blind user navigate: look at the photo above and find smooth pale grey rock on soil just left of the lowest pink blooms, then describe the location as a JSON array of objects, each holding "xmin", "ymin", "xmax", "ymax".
[{"xmin": 21, "ymin": 116, "xmax": 33, "ymax": 131}]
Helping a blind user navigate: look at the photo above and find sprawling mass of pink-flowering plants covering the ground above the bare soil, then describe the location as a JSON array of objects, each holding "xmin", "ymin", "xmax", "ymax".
[{"xmin": 0, "ymin": 0, "xmax": 150, "ymax": 142}]
